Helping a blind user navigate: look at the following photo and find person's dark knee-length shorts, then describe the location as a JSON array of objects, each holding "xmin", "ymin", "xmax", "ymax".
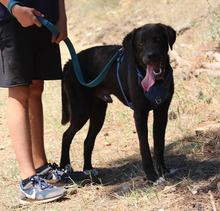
[{"xmin": 0, "ymin": 20, "xmax": 62, "ymax": 87}]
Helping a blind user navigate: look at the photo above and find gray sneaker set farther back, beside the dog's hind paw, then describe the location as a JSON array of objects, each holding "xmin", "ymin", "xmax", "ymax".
[{"xmin": 37, "ymin": 163, "xmax": 69, "ymax": 184}]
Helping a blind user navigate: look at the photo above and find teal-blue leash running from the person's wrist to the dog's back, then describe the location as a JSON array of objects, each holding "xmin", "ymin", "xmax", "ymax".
[{"xmin": 8, "ymin": 1, "xmax": 121, "ymax": 87}]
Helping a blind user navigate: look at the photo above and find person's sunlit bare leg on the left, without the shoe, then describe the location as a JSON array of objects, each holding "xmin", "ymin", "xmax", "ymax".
[{"xmin": 8, "ymin": 86, "xmax": 36, "ymax": 179}]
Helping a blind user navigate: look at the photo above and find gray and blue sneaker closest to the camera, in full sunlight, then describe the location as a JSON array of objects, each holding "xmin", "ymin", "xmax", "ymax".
[{"xmin": 20, "ymin": 176, "xmax": 66, "ymax": 204}]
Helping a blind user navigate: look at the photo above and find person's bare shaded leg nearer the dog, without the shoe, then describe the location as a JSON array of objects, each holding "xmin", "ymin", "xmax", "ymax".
[{"xmin": 29, "ymin": 80, "xmax": 47, "ymax": 169}]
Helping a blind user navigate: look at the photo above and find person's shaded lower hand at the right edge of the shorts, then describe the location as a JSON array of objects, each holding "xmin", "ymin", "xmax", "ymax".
[{"xmin": 51, "ymin": 17, "xmax": 67, "ymax": 44}]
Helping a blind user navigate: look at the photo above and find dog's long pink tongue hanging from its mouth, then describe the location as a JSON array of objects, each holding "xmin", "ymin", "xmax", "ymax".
[{"xmin": 141, "ymin": 65, "xmax": 157, "ymax": 92}]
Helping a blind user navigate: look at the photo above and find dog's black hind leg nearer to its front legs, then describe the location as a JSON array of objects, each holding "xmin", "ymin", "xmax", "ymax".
[{"xmin": 83, "ymin": 98, "xmax": 107, "ymax": 170}]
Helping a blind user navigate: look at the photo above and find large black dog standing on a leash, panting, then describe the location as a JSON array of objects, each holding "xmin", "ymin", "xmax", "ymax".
[{"xmin": 60, "ymin": 24, "xmax": 176, "ymax": 181}]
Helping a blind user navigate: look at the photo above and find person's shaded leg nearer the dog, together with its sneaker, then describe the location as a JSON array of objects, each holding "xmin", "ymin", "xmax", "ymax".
[{"xmin": 29, "ymin": 80, "xmax": 68, "ymax": 183}]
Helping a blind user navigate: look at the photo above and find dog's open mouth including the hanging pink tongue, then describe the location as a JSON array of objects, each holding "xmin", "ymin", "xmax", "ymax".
[{"xmin": 141, "ymin": 62, "xmax": 164, "ymax": 92}]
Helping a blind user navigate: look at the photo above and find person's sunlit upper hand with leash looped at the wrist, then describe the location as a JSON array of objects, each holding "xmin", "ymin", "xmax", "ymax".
[{"xmin": 11, "ymin": 4, "xmax": 44, "ymax": 27}]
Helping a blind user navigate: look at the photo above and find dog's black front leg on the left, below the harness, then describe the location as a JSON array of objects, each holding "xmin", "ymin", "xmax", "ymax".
[{"xmin": 134, "ymin": 111, "xmax": 158, "ymax": 182}]
